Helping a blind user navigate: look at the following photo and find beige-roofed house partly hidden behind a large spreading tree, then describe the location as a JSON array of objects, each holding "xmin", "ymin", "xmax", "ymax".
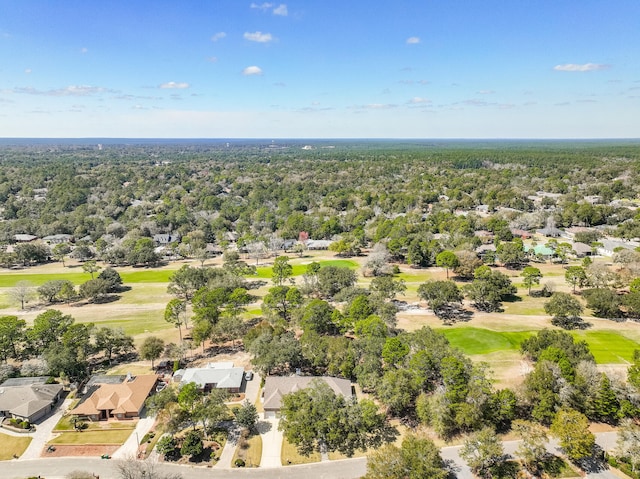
[{"xmin": 263, "ymin": 376, "xmax": 353, "ymax": 418}]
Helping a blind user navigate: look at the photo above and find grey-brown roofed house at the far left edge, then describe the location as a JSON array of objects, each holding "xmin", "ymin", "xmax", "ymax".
[{"xmin": 0, "ymin": 377, "xmax": 62, "ymax": 423}]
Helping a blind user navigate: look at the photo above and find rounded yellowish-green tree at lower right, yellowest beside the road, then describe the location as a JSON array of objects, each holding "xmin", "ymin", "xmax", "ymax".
[{"xmin": 550, "ymin": 409, "xmax": 596, "ymax": 461}]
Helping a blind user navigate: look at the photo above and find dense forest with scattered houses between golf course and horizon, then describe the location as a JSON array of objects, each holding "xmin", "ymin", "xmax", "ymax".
[{"xmin": 0, "ymin": 142, "xmax": 640, "ymax": 246}]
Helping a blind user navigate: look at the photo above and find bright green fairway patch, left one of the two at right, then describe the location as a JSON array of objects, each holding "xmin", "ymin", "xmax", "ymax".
[{"xmin": 438, "ymin": 327, "xmax": 533, "ymax": 355}]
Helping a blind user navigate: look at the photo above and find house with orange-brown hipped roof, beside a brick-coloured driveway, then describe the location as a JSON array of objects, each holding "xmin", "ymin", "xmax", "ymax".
[{"xmin": 71, "ymin": 374, "xmax": 158, "ymax": 421}]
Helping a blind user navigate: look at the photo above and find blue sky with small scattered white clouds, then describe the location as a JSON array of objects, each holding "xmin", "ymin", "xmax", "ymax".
[{"xmin": 0, "ymin": 0, "xmax": 640, "ymax": 138}]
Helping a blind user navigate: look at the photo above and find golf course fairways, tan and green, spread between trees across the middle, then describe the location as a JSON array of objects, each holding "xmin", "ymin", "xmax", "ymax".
[{"xmin": 0, "ymin": 251, "xmax": 640, "ymax": 379}]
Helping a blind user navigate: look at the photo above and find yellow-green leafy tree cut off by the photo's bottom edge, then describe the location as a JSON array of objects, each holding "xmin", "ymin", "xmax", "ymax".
[{"xmin": 364, "ymin": 434, "xmax": 450, "ymax": 479}]
